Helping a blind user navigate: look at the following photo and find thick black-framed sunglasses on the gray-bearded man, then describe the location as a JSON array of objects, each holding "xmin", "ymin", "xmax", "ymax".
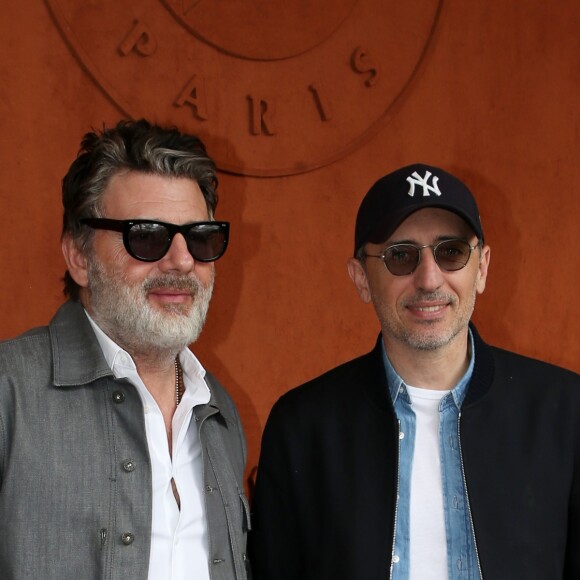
[{"xmin": 81, "ymin": 218, "xmax": 230, "ymax": 262}]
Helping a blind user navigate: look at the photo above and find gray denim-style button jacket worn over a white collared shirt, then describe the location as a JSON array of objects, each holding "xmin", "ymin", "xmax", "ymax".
[{"xmin": 0, "ymin": 302, "xmax": 249, "ymax": 580}]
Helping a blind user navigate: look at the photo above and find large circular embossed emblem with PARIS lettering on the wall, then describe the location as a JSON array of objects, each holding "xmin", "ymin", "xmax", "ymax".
[{"xmin": 46, "ymin": 0, "xmax": 443, "ymax": 176}]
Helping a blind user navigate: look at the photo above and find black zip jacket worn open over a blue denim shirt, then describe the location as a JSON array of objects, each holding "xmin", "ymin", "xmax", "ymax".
[{"xmin": 250, "ymin": 327, "xmax": 580, "ymax": 580}]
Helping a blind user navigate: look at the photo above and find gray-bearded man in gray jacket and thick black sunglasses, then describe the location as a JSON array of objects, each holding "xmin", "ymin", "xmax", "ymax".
[{"xmin": 0, "ymin": 120, "xmax": 249, "ymax": 580}]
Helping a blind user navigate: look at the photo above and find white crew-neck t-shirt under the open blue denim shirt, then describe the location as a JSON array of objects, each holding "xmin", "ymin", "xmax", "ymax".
[{"xmin": 407, "ymin": 385, "xmax": 449, "ymax": 580}]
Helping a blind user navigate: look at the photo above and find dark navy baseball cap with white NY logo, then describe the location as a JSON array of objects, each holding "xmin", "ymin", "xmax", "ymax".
[{"xmin": 354, "ymin": 163, "xmax": 483, "ymax": 257}]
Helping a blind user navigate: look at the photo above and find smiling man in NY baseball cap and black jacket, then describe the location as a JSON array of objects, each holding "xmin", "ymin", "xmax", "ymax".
[{"xmin": 251, "ymin": 164, "xmax": 580, "ymax": 580}]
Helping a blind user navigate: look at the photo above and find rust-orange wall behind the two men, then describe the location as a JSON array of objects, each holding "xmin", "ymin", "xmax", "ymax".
[{"xmin": 0, "ymin": 0, "xmax": 580, "ymax": 478}]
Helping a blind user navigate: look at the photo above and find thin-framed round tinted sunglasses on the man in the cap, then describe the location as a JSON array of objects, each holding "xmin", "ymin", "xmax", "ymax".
[{"xmin": 366, "ymin": 240, "xmax": 478, "ymax": 276}]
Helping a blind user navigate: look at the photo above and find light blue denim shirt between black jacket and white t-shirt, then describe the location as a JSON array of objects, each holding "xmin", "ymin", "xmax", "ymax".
[{"xmin": 383, "ymin": 330, "xmax": 481, "ymax": 580}]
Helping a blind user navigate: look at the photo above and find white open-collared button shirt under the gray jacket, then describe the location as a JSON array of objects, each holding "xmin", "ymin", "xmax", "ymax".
[{"xmin": 87, "ymin": 314, "xmax": 211, "ymax": 580}]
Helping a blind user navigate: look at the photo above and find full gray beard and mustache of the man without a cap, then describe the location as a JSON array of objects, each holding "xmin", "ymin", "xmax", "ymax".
[{"xmin": 88, "ymin": 257, "xmax": 213, "ymax": 356}]
